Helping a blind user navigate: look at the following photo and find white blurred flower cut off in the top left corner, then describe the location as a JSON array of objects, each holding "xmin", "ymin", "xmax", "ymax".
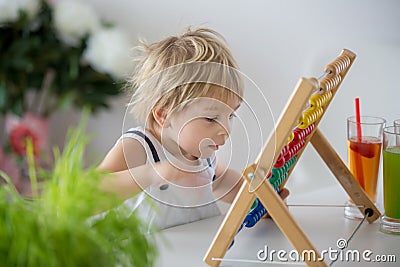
[{"xmin": 0, "ymin": 0, "xmax": 40, "ymax": 23}]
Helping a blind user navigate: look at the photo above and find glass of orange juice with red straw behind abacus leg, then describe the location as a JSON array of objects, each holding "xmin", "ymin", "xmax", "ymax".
[{"xmin": 344, "ymin": 116, "xmax": 386, "ymax": 219}]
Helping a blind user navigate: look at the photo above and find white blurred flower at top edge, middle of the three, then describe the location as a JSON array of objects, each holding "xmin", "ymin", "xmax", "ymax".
[{"xmin": 54, "ymin": 0, "xmax": 100, "ymax": 46}]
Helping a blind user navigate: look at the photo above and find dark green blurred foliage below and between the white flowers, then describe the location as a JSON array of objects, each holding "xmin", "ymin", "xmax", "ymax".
[{"xmin": 0, "ymin": 0, "xmax": 122, "ymax": 114}]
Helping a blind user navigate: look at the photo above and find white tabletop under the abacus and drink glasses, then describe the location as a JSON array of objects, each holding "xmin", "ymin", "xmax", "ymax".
[{"xmin": 156, "ymin": 185, "xmax": 400, "ymax": 267}]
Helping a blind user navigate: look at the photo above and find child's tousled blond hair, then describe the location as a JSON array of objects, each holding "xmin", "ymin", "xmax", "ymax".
[{"xmin": 128, "ymin": 28, "xmax": 243, "ymax": 127}]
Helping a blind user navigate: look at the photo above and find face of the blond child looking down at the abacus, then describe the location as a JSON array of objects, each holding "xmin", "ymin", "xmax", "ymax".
[{"xmin": 162, "ymin": 90, "xmax": 241, "ymax": 159}]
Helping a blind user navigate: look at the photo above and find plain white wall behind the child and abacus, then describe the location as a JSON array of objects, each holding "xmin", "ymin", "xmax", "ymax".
[{"xmin": 61, "ymin": 0, "xmax": 400, "ymax": 199}]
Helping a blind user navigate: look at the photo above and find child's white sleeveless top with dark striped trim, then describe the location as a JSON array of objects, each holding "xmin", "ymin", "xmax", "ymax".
[{"xmin": 118, "ymin": 127, "xmax": 221, "ymax": 229}]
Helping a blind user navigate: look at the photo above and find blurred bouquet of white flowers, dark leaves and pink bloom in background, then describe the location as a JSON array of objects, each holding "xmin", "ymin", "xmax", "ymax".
[{"xmin": 0, "ymin": 0, "xmax": 131, "ymax": 193}]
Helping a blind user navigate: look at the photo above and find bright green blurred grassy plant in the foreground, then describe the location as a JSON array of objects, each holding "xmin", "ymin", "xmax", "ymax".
[{"xmin": 0, "ymin": 120, "xmax": 157, "ymax": 267}]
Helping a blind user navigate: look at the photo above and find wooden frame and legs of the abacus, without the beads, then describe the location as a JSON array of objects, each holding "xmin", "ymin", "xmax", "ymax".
[{"xmin": 204, "ymin": 49, "xmax": 380, "ymax": 267}]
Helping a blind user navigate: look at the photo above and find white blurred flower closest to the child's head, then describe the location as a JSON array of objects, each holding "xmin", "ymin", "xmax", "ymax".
[{"xmin": 83, "ymin": 27, "xmax": 133, "ymax": 79}]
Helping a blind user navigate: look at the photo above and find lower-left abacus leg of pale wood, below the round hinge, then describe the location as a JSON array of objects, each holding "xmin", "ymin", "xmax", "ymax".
[{"xmin": 203, "ymin": 176, "xmax": 255, "ymax": 267}]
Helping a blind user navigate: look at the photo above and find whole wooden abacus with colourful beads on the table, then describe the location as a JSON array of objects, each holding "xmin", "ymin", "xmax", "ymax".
[{"xmin": 204, "ymin": 49, "xmax": 380, "ymax": 266}]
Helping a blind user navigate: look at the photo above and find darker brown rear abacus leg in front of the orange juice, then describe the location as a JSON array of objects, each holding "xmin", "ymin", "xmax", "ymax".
[{"xmin": 311, "ymin": 129, "xmax": 381, "ymax": 223}]
